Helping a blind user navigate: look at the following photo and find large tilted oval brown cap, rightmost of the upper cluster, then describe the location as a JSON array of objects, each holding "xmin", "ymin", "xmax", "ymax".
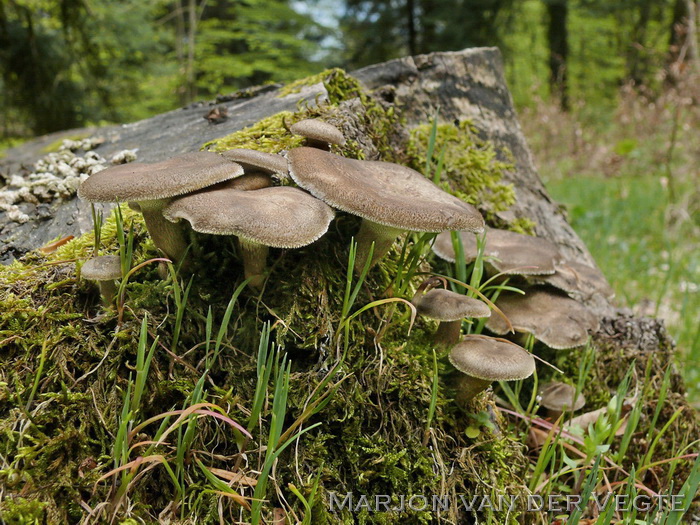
[{"xmin": 287, "ymin": 147, "xmax": 484, "ymax": 232}]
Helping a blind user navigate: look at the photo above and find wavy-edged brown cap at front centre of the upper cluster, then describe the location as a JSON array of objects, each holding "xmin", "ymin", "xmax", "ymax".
[{"xmin": 163, "ymin": 186, "xmax": 335, "ymax": 248}]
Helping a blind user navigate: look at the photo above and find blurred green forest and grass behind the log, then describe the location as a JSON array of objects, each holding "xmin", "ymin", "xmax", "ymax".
[{"xmin": 0, "ymin": 0, "xmax": 700, "ymax": 406}]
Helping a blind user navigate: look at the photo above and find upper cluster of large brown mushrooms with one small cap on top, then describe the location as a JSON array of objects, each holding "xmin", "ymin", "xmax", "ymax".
[{"xmin": 78, "ymin": 119, "xmax": 484, "ymax": 289}]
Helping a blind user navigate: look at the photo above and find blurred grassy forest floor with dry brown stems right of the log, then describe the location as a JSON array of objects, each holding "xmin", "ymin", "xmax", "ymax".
[{"xmin": 520, "ymin": 79, "xmax": 700, "ymax": 407}]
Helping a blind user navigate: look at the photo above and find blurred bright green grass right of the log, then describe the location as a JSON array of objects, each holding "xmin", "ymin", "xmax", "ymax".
[{"xmin": 547, "ymin": 175, "xmax": 700, "ymax": 404}]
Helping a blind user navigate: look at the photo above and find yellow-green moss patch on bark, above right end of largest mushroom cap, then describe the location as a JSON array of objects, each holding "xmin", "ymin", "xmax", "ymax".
[{"xmin": 407, "ymin": 122, "xmax": 515, "ymax": 221}]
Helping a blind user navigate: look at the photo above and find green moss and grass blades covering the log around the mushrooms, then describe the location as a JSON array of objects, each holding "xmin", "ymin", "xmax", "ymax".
[{"xmin": 0, "ymin": 72, "xmax": 698, "ymax": 524}]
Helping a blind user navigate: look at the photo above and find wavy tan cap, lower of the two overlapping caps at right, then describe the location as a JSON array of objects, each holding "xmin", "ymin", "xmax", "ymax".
[{"xmin": 486, "ymin": 287, "xmax": 599, "ymax": 350}]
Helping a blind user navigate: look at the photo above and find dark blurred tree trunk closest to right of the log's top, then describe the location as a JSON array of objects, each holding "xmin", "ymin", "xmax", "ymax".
[{"xmin": 547, "ymin": 0, "xmax": 569, "ymax": 110}]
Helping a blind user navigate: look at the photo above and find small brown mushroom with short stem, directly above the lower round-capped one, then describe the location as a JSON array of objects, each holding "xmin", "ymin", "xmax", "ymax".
[{"xmin": 411, "ymin": 281, "xmax": 491, "ymax": 346}]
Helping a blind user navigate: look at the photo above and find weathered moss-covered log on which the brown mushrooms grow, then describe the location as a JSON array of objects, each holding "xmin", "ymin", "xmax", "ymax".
[{"xmin": 0, "ymin": 49, "xmax": 700, "ymax": 524}]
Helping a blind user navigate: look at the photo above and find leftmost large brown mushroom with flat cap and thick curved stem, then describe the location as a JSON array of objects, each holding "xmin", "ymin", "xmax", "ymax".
[{"xmin": 78, "ymin": 151, "xmax": 243, "ymax": 262}]
